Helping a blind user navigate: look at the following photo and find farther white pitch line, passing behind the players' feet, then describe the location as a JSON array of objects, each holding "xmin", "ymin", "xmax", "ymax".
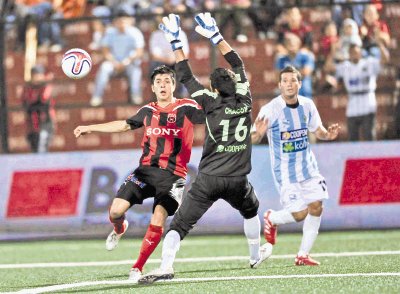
[{"xmin": 0, "ymin": 251, "xmax": 400, "ymax": 269}]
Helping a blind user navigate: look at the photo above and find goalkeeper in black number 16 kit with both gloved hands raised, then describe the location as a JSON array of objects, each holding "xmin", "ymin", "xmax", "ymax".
[{"xmin": 139, "ymin": 13, "xmax": 272, "ymax": 284}]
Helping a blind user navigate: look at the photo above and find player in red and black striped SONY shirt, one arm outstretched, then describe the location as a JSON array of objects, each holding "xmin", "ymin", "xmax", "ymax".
[{"xmin": 74, "ymin": 66, "xmax": 204, "ymax": 281}]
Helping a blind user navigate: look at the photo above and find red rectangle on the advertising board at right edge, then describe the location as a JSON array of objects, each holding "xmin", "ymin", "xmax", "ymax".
[{"xmin": 339, "ymin": 158, "xmax": 400, "ymax": 205}]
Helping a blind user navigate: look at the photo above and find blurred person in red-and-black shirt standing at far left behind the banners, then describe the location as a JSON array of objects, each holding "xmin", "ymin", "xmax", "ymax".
[{"xmin": 21, "ymin": 65, "xmax": 55, "ymax": 153}]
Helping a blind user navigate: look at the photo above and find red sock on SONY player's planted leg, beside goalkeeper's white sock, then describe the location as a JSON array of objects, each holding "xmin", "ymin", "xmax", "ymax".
[{"xmin": 132, "ymin": 224, "xmax": 163, "ymax": 271}]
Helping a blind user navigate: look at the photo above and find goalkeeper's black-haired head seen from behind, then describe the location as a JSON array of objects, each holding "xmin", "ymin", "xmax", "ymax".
[{"xmin": 210, "ymin": 67, "xmax": 236, "ymax": 97}]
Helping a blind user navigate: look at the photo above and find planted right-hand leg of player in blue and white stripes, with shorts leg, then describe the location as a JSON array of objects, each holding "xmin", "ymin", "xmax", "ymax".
[{"xmin": 295, "ymin": 176, "xmax": 328, "ymax": 265}]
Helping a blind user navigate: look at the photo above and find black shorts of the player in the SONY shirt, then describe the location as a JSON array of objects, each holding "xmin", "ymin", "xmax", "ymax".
[{"xmin": 116, "ymin": 166, "xmax": 185, "ymax": 216}]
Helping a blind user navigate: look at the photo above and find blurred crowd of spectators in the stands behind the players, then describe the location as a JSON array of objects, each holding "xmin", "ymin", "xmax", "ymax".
[{"xmin": 1, "ymin": 0, "xmax": 393, "ymax": 152}]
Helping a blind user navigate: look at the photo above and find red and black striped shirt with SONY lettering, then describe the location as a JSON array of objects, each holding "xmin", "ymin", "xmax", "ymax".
[{"xmin": 126, "ymin": 99, "xmax": 205, "ymax": 177}]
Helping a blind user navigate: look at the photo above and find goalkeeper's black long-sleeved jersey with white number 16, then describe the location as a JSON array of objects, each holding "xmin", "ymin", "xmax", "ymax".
[{"xmin": 175, "ymin": 50, "xmax": 252, "ymax": 176}]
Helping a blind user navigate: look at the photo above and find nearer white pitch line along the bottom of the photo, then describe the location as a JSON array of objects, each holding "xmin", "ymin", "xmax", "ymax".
[{"xmin": 8, "ymin": 273, "xmax": 400, "ymax": 294}]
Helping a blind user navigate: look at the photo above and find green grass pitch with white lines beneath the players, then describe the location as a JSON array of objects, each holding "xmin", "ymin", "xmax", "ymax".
[{"xmin": 0, "ymin": 230, "xmax": 400, "ymax": 294}]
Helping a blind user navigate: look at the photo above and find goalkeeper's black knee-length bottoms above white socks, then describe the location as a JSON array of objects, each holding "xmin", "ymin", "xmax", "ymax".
[{"xmin": 170, "ymin": 173, "xmax": 259, "ymax": 239}]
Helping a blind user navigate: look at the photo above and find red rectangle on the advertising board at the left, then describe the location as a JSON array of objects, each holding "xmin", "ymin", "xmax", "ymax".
[{"xmin": 7, "ymin": 169, "xmax": 83, "ymax": 218}]
